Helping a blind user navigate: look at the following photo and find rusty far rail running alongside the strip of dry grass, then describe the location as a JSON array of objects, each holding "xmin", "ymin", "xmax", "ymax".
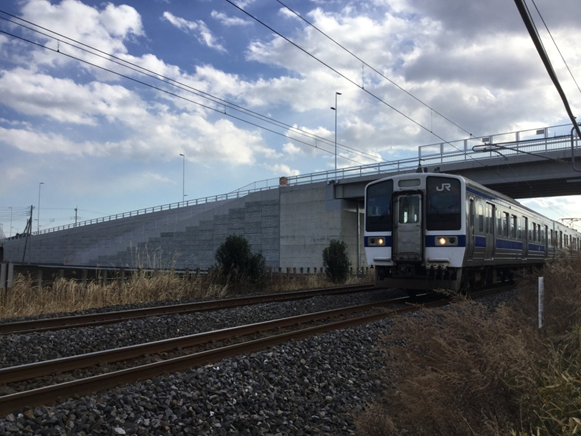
[{"xmin": 0, "ymin": 285, "xmax": 374, "ymax": 335}]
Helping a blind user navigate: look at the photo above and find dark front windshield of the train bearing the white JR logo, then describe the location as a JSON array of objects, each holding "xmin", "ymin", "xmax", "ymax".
[{"xmin": 426, "ymin": 177, "xmax": 461, "ymax": 230}]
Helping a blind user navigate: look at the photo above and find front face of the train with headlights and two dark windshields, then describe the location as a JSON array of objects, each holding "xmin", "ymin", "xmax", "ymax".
[{"xmin": 364, "ymin": 173, "xmax": 466, "ymax": 293}]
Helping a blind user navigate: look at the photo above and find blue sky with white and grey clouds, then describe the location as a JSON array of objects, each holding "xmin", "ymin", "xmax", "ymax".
[{"xmin": 0, "ymin": 0, "xmax": 582, "ymax": 236}]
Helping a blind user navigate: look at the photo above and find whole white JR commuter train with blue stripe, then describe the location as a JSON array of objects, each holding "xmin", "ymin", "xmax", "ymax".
[{"xmin": 364, "ymin": 173, "xmax": 580, "ymax": 295}]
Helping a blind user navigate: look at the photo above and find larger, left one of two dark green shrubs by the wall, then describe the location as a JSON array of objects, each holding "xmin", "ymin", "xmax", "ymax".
[{"xmin": 214, "ymin": 235, "xmax": 267, "ymax": 285}]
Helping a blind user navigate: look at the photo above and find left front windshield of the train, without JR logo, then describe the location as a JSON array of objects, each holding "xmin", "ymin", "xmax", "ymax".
[{"xmin": 366, "ymin": 180, "xmax": 394, "ymax": 232}]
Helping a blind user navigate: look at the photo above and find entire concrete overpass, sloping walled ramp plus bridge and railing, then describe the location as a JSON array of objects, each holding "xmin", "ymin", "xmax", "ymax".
[{"xmin": 3, "ymin": 129, "xmax": 580, "ymax": 270}]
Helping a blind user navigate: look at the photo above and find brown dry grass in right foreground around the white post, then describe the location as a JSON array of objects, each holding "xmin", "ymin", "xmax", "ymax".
[{"xmin": 356, "ymin": 253, "xmax": 581, "ymax": 436}]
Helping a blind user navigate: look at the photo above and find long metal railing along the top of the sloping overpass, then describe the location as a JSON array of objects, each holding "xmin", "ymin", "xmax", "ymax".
[{"xmin": 33, "ymin": 124, "xmax": 580, "ymax": 235}]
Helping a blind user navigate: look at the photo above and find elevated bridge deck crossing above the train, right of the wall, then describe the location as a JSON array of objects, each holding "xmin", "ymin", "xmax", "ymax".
[{"xmin": 329, "ymin": 136, "xmax": 580, "ymax": 200}]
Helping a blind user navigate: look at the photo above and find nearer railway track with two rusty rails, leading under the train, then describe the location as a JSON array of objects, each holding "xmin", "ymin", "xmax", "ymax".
[{"xmin": 0, "ymin": 289, "xmax": 512, "ymax": 416}]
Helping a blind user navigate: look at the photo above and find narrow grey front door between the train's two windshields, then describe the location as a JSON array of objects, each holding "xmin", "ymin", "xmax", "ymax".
[{"xmin": 392, "ymin": 193, "xmax": 424, "ymax": 262}]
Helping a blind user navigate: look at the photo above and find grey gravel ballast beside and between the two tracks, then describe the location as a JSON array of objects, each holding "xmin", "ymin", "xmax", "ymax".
[{"xmin": 0, "ymin": 291, "xmax": 507, "ymax": 436}]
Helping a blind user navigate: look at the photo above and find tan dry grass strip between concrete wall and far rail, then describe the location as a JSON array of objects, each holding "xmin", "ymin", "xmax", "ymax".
[{"xmin": 0, "ymin": 271, "xmax": 372, "ymax": 318}]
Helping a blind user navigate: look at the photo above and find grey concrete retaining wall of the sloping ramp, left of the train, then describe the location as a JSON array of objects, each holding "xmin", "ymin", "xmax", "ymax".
[{"xmin": 4, "ymin": 182, "xmax": 365, "ymax": 270}]
